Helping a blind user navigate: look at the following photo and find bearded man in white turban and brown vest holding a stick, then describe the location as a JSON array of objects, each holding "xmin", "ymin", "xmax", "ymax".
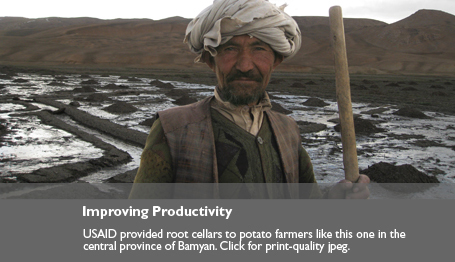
[{"xmin": 131, "ymin": 0, "xmax": 369, "ymax": 198}]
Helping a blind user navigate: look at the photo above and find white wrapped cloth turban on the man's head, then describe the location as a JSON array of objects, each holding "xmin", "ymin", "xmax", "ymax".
[{"xmin": 184, "ymin": 0, "xmax": 302, "ymax": 62}]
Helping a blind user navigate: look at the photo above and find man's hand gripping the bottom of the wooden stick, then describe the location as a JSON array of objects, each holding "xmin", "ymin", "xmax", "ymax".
[{"xmin": 327, "ymin": 175, "xmax": 370, "ymax": 199}]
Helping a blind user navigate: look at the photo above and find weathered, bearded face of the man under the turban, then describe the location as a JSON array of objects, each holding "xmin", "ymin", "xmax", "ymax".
[{"xmin": 206, "ymin": 35, "xmax": 283, "ymax": 105}]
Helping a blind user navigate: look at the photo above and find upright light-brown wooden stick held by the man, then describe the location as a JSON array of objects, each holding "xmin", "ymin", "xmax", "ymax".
[{"xmin": 329, "ymin": 6, "xmax": 359, "ymax": 182}]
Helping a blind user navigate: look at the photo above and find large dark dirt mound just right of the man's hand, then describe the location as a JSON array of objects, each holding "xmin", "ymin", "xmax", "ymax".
[{"xmin": 361, "ymin": 162, "xmax": 439, "ymax": 191}]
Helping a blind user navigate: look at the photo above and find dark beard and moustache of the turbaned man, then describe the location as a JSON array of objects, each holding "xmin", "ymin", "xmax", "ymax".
[{"xmin": 217, "ymin": 70, "xmax": 266, "ymax": 106}]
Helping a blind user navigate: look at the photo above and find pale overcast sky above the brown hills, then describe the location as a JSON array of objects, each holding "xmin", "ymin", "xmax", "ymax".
[{"xmin": 0, "ymin": 0, "xmax": 455, "ymax": 23}]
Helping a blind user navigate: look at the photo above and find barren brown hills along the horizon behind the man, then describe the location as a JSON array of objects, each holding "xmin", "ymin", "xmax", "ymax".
[{"xmin": 0, "ymin": 10, "xmax": 455, "ymax": 75}]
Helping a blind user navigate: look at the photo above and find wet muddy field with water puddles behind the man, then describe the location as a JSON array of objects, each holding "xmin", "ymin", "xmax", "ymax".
[{"xmin": 0, "ymin": 67, "xmax": 455, "ymax": 199}]
